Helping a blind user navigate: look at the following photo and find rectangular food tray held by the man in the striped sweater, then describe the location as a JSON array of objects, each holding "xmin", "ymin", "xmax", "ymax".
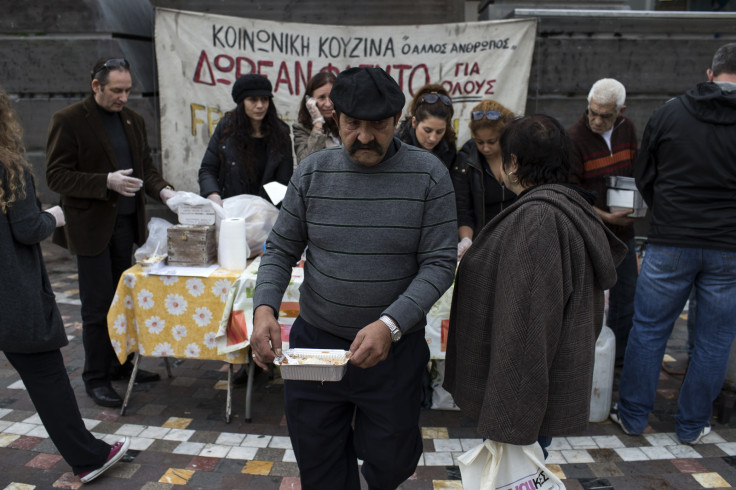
[{"xmin": 274, "ymin": 349, "xmax": 350, "ymax": 382}]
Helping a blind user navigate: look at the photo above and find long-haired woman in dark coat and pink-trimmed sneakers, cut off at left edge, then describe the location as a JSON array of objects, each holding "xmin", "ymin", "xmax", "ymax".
[{"xmin": 0, "ymin": 89, "xmax": 130, "ymax": 483}]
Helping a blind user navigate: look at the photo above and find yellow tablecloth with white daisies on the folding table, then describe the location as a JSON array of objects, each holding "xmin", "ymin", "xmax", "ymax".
[{"xmin": 107, "ymin": 265, "xmax": 247, "ymax": 364}]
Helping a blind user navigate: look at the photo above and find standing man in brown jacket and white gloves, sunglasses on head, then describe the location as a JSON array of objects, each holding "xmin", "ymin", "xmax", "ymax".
[{"xmin": 46, "ymin": 58, "xmax": 174, "ymax": 407}]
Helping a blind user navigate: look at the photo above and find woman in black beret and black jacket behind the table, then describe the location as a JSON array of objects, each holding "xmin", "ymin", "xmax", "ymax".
[{"xmin": 199, "ymin": 74, "xmax": 294, "ymax": 205}]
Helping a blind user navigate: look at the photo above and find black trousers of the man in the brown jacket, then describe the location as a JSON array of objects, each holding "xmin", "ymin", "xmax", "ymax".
[{"xmin": 77, "ymin": 214, "xmax": 136, "ymax": 388}]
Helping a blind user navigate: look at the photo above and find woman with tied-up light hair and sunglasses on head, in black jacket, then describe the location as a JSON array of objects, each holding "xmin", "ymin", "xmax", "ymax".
[{"xmin": 450, "ymin": 100, "xmax": 516, "ymax": 260}]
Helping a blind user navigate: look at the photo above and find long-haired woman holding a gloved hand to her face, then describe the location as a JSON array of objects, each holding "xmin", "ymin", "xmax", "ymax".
[{"xmin": 291, "ymin": 71, "xmax": 341, "ymax": 164}]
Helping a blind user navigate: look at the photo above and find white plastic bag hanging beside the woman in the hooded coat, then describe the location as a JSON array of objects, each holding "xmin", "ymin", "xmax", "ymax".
[{"xmin": 457, "ymin": 440, "xmax": 565, "ymax": 490}]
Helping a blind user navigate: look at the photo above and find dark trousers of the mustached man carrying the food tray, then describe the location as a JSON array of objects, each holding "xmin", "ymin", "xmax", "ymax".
[{"xmin": 284, "ymin": 317, "xmax": 429, "ymax": 490}]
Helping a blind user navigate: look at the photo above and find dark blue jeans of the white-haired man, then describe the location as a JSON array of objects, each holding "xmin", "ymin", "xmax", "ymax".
[{"xmin": 608, "ymin": 238, "xmax": 639, "ymax": 365}]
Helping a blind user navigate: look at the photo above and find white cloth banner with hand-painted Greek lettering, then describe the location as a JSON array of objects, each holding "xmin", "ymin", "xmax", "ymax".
[{"xmin": 155, "ymin": 8, "xmax": 536, "ymax": 192}]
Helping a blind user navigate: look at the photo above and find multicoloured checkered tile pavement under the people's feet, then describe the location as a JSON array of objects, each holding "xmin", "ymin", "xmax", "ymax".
[{"xmin": 0, "ymin": 240, "xmax": 736, "ymax": 490}]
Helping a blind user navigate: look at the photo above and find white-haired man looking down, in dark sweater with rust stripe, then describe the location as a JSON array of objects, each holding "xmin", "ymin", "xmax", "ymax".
[{"xmin": 568, "ymin": 78, "xmax": 638, "ymax": 366}]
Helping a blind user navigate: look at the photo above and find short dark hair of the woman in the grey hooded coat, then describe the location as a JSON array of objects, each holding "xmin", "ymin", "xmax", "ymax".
[{"xmin": 501, "ymin": 114, "xmax": 570, "ymax": 187}]
